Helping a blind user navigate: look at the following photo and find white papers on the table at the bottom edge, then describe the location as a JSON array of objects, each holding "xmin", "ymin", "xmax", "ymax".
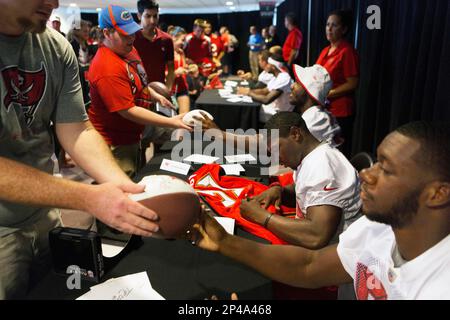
[{"xmin": 77, "ymin": 271, "xmax": 165, "ymax": 300}]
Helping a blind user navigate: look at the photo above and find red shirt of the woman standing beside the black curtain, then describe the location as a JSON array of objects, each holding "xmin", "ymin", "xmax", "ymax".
[{"xmin": 316, "ymin": 40, "xmax": 359, "ymax": 117}]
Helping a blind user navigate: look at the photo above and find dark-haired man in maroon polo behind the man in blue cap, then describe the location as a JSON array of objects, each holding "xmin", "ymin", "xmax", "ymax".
[{"xmin": 134, "ymin": 0, "xmax": 175, "ymax": 89}]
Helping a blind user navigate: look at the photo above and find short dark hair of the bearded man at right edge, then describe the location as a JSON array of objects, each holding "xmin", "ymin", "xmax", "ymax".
[{"xmin": 395, "ymin": 121, "xmax": 450, "ymax": 182}]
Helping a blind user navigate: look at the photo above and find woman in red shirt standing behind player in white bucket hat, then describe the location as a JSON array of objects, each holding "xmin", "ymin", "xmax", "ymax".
[{"xmin": 316, "ymin": 10, "xmax": 359, "ymax": 157}]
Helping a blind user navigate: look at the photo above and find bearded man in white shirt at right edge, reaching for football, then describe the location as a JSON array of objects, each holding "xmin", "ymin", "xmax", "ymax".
[{"xmin": 191, "ymin": 122, "xmax": 450, "ymax": 300}]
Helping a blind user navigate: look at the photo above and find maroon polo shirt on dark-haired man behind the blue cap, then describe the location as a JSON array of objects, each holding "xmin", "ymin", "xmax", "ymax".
[{"xmin": 133, "ymin": 28, "xmax": 173, "ymax": 83}]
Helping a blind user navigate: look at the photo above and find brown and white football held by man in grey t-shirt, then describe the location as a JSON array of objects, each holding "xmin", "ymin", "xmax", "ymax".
[{"xmin": 129, "ymin": 175, "xmax": 201, "ymax": 239}]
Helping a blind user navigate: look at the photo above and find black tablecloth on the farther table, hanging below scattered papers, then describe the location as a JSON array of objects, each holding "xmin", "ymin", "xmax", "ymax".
[{"xmin": 195, "ymin": 89, "xmax": 261, "ymax": 130}]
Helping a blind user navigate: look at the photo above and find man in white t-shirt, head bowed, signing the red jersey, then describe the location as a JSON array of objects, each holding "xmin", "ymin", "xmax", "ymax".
[{"xmin": 240, "ymin": 112, "xmax": 361, "ymax": 249}]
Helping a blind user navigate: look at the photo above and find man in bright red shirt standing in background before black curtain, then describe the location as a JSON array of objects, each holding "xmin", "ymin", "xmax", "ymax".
[{"xmin": 283, "ymin": 12, "xmax": 303, "ymax": 68}]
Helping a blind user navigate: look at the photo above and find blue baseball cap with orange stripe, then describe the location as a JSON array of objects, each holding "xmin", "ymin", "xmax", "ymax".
[{"xmin": 98, "ymin": 4, "xmax": 142, "ymax": 36}]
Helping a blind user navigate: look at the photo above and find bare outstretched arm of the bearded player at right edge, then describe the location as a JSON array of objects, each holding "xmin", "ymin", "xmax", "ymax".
[{"xmin": 193, "ymin": 214, "xmax": 352, "ymax": 288}]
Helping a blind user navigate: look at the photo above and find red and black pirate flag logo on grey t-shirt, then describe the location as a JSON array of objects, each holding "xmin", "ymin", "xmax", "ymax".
[{"xmin": 1, "ymin": 63, "xmax": 47, "ymax": 127}]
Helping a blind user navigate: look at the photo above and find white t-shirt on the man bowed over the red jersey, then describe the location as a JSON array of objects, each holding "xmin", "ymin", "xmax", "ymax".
[{"xmin": 294, "ymin": 141, "xmax": 362, "ymax": 243}]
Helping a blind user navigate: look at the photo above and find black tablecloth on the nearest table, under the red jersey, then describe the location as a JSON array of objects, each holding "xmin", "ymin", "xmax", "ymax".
[{"xmin": 27, "ymin": 143, "xmax": 272, "ymax": 299}]
